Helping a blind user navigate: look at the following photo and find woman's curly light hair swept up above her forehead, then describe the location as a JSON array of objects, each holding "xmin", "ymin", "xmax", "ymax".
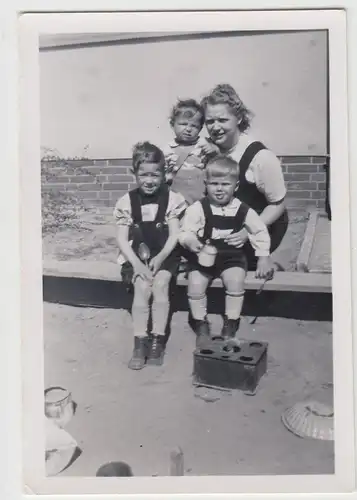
[{"xmin": 201, "ymin": 83, "xmax": 253, "ymax": 132}]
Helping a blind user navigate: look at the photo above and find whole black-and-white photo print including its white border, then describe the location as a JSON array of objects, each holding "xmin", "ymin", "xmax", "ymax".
[{"xmin": 18, "ymin": 8, "xmax": 353, "ymax": 493}]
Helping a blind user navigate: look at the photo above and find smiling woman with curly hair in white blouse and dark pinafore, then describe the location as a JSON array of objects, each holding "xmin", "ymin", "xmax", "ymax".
[{"xmin": 201, "ymin": 84, "xmax": 288, "ymax": 270}]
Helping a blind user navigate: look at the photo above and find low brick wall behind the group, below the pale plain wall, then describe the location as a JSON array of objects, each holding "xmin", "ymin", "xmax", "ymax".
[{"xmin": 42, "ymin": 156, "xmax": 326, "ymax": 208}]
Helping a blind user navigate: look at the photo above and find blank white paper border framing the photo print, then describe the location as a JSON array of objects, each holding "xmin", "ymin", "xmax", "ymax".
[{"xmin": 4, "ymin": 4, "xmax": 355, "ymax": 498}]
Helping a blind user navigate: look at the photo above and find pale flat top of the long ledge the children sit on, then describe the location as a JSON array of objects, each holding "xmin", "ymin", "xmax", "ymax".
[{"xmin": 43, "ymin": 260, "xmax": 332, "ymax": 293}]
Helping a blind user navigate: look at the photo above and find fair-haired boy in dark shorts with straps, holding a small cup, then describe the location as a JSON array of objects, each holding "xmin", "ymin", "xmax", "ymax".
[{"xmin": 179, "ymin": 155, "xmax": 274, "ymax": 345}]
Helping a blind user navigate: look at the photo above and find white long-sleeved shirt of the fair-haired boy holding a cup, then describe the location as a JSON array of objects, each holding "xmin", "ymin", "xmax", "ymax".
[{"xmin": 179, "ymin": 198, "xmax": 270, "ymax": 257}]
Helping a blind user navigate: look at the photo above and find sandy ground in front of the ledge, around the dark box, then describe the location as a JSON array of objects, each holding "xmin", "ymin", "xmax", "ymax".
[{"xmin": 44, "ymin": 304, "xmax": 334, "ymax": 476}]
